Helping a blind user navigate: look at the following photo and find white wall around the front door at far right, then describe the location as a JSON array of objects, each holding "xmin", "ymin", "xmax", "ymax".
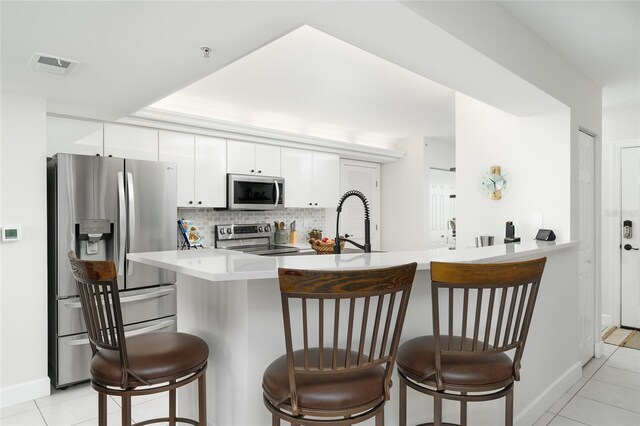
[{"xmin": 601, "ymin": 106, "xmax": 640, "ymax": 326}]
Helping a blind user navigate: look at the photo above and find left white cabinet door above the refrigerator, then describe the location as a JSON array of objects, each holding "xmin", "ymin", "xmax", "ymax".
[{"xmin": 47, "ymin": 117, "xmax": 103, "ymax": 157}]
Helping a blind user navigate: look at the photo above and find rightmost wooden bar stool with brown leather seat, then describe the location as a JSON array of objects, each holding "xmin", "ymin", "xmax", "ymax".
[{"xmin": 397, "ymin": 258, "xmax": 547, "ymax": 426}]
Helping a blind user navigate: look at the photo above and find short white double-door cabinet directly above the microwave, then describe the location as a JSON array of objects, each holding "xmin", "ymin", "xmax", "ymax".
[{"xmin": 227, "ymin": 140, "xmax": 280, "ymax": 176}]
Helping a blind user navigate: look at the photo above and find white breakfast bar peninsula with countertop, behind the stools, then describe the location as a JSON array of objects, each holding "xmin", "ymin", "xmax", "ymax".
[{"xmin": 128, "ymin": 241, "xmax": 581, "ymax": 426}]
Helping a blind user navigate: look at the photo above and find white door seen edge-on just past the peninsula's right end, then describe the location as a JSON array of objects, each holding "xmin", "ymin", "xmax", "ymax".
[{"xmin": 578, "ymin": 132, "xmax": 595, "ymax": 365}]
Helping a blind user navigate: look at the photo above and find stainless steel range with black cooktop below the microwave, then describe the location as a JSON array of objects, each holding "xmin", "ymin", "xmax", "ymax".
[{"xmin": 215, "ymin": 223, "xmax": 300, "ymax": 255}]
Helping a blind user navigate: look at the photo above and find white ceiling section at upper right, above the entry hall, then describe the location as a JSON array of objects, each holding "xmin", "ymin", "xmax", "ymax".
[{"xmin": 500, "ymin": 0, "xmax": 640, "ymax": 108}]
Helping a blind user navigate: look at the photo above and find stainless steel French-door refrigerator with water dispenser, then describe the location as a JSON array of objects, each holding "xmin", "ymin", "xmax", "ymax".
[{"xmin": 47, "ymin": 154, "xmax": 177, "ymax": 388}]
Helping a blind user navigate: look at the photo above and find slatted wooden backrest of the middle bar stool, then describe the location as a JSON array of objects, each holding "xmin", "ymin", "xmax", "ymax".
[{"xmin": 278, "ymin": 263, "xmax": 417, "ymax": 410}]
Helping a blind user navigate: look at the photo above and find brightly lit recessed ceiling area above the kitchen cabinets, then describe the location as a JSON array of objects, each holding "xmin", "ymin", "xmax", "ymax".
[{"xmin": 151, "ymin": 26, "xmax": 455, "ymax": 147}]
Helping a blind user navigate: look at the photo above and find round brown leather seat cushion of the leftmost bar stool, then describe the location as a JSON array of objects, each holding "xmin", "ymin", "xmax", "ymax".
[{"xmin": 91, "ymin": 332, "xmax": 209, "ymax": 386}]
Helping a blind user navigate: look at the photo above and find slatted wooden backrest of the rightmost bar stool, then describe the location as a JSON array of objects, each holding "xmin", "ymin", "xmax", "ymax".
[{"xmin": 431, "ymin": 257, "xmax": 547, "ymax": 390}]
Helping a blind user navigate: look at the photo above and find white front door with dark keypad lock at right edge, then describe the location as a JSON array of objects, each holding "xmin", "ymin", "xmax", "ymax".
[{"xmin": 620, "ymin": 147, "xmax": 640, "ymax": 328}]
